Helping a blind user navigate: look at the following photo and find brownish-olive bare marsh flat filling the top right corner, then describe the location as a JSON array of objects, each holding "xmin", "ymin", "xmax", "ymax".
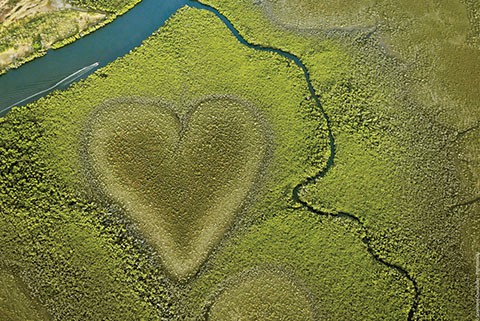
[{"xmin": 263, "ymin": 0, "xmax": 480, "ymax": 129}]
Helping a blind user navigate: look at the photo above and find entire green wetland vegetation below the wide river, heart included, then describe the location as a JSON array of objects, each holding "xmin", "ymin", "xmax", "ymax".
[{"xmin": 0, "ymin": 0, "xmax": 480, "ymax": 320}]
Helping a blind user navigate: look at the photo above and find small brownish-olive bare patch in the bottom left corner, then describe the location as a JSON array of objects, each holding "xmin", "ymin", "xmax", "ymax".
[{"xmin": 0, "ymin": 270, "xmax": 50, "ymax": 321}]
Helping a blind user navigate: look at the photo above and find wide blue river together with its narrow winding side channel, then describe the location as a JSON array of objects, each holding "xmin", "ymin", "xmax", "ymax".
[{"xmin": 0, "ymin": 0, "xmax": 419, "ymax": 320}]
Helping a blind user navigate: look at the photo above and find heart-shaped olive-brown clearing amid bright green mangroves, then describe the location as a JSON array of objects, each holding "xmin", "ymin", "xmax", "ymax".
[{"xmin": 86, "ymin": 97, "xmax": 267, "ymax": 279}]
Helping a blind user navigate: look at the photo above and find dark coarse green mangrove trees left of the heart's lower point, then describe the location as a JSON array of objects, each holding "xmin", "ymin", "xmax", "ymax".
[{"xmin": 0, "ymin": 109, "xmax": 176, "ymax": 320}]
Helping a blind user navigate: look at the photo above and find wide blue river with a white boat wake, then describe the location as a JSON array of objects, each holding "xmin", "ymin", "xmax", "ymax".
[{"xmin": 0, "ymin": 0, "xmax": 195, "ymax": 116}]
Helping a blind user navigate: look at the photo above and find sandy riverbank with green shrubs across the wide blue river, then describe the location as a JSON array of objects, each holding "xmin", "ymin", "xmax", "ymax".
[{"xmin": 0, "ymin": 0, "xmax": 141, "ymax": 75}]
